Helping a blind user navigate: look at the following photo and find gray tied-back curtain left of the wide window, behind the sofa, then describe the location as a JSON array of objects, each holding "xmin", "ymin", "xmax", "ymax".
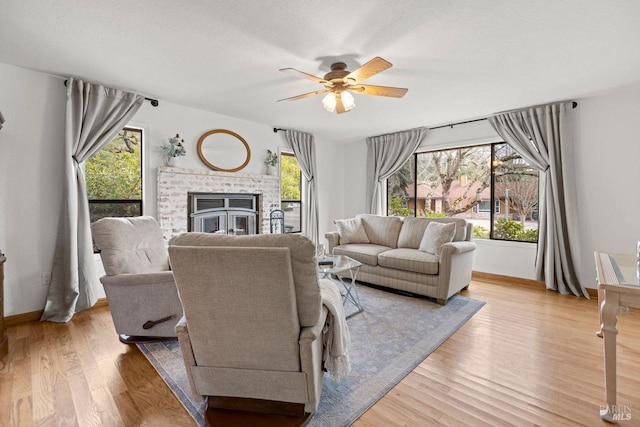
[{"xmin": 367, "ymin": 128, "xmax": 429, "ymax": 215}]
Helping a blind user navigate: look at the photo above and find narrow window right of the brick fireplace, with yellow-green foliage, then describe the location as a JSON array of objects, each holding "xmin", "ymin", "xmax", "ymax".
[{"xmin": 280, "ymin": 153, "xmax": 302, "ymax": 233}]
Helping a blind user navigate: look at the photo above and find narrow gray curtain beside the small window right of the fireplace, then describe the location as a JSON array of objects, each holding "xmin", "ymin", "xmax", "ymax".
[{"xmin": 284, "ymin": 130, "xmax": 320, "ymax": 246}]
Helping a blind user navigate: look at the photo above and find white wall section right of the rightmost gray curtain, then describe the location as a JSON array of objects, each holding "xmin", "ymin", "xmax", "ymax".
[{"xmin": 575, "ymin": 85, "xmax": 640, "ymax": 287}]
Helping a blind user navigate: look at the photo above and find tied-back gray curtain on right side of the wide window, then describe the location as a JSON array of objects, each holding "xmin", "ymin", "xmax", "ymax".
[{"xmin": 489, "ymin": 103, "xmax": 589, "ymax": 298}]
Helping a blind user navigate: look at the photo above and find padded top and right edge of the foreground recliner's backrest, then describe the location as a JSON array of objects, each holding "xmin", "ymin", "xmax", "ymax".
[{"xmin": 169, "ymin": 233, "xmax": 322, "ymax": 326}]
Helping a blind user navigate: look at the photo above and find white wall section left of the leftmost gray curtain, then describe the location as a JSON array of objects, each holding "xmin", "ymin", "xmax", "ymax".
[{"xmin": 0, "ymin": 64, "xmax": 65, "ymax": 315}]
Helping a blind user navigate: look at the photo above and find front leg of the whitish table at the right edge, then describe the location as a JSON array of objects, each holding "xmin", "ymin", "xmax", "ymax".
[{"xmin": 600, "ymin": 290, "xmax": 620, "ymax": 423}]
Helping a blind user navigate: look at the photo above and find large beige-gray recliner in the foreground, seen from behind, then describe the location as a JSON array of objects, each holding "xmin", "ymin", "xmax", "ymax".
[{"xmin": 169, "ymin": 233, "xmax": 327, "ymax": 417}]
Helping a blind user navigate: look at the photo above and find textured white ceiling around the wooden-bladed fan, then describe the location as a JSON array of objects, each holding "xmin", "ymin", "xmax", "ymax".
[{"xmin": 0, "ymin": 0, "xmax": 640, "ymax": 141}]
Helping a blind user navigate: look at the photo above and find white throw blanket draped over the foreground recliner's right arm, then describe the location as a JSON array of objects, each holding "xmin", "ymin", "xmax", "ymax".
[{"xmin": 320, "ymin": 280, "xmax": 351, "ymax": 381}]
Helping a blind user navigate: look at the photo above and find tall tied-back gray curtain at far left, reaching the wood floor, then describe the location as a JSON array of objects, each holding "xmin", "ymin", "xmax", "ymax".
[{"xmin": 40, "ymin": 78, "xmax": 144, "ymax": 322}]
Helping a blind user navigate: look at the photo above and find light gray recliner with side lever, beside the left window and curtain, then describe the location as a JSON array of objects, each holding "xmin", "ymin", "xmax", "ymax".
[{"xmin": 91, "ymin": 216, "xmax": 182, "ymax": 343}]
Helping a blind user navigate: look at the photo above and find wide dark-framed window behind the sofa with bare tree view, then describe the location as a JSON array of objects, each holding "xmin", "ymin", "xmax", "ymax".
[{"xmin": 387, "ymin": 143, "xmax": 539, "ymax": 242}]
